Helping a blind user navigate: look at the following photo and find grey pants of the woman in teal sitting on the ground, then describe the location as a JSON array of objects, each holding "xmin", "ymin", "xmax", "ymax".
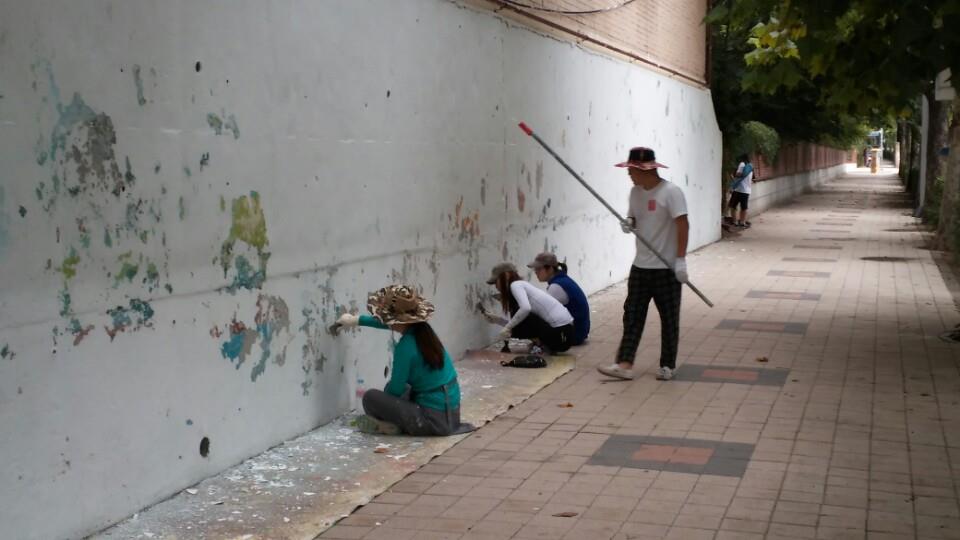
[{"xmin": 363, "ymin": 389, "xmax": 460, "ymax": 436}]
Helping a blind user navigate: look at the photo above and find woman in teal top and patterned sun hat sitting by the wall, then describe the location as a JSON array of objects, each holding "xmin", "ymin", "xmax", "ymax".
[{"xmin": 337, "ymin": 285, "xmax": 474, "ymax": 436}]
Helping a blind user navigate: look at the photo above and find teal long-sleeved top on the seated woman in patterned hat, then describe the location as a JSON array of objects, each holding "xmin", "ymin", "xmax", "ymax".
[{"xmin": 360, "ymin": 315, "xmax": 460, "ymax": 411}]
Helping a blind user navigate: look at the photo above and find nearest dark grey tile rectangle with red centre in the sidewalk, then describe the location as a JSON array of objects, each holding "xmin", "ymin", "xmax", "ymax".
[{"xmin": 588, "ymin": 435, "xmax": 754, "ymax": 477}]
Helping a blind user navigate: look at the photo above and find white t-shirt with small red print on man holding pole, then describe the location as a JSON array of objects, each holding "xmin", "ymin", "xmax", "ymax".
[{"xmin": 627, "ymin": 180, "xmax": 687, "ymax": 268}]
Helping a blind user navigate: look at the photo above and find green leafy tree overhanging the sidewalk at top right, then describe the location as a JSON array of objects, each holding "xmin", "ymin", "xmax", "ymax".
[{"xmin": 707, "ymin": 0, "xmax": 960, "ymax": 249}]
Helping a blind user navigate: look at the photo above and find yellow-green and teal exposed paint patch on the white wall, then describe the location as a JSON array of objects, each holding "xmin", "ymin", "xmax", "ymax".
[{"xmin": 220, "ymin": 191, "xmax": 270, "ymax": 293}]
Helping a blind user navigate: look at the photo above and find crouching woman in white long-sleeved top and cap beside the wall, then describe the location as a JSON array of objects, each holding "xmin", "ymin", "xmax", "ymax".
[{"xmin": 487, "ymin": 263, "xmax": 574, "ymax": 355}]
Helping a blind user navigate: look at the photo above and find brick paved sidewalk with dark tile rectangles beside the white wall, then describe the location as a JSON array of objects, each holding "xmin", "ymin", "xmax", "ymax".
[{"xmin": 321, "ymin": 169, "xmax": 960, "ymax": 540}]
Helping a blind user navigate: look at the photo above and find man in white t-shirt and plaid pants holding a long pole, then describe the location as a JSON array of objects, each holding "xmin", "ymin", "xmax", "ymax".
[{"xmin": 597, "ymin": 147, "xmax": 690, "ymax": 381}]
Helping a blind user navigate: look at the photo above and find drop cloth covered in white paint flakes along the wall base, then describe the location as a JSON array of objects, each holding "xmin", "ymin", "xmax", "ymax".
[{"xmin": 91, "ymin": 351, "xmax": 574, "ymax": 540}]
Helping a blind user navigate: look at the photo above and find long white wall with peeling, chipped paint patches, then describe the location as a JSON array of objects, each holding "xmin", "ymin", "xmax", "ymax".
[{"xmin": 0, "ymin": 0, "xmax": 720, "ymax": 539}]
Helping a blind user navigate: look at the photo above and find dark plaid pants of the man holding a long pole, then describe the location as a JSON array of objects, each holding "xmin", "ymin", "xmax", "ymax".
[{"xmin": 617, "ymin": 266, "xmax": 683, "ymax": 369}]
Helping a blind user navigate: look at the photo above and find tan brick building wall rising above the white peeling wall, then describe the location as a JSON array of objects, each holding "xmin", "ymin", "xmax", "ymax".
[{"xmin": 467, "ymin": 0, "xmax": 707, "ymax": 86}]
